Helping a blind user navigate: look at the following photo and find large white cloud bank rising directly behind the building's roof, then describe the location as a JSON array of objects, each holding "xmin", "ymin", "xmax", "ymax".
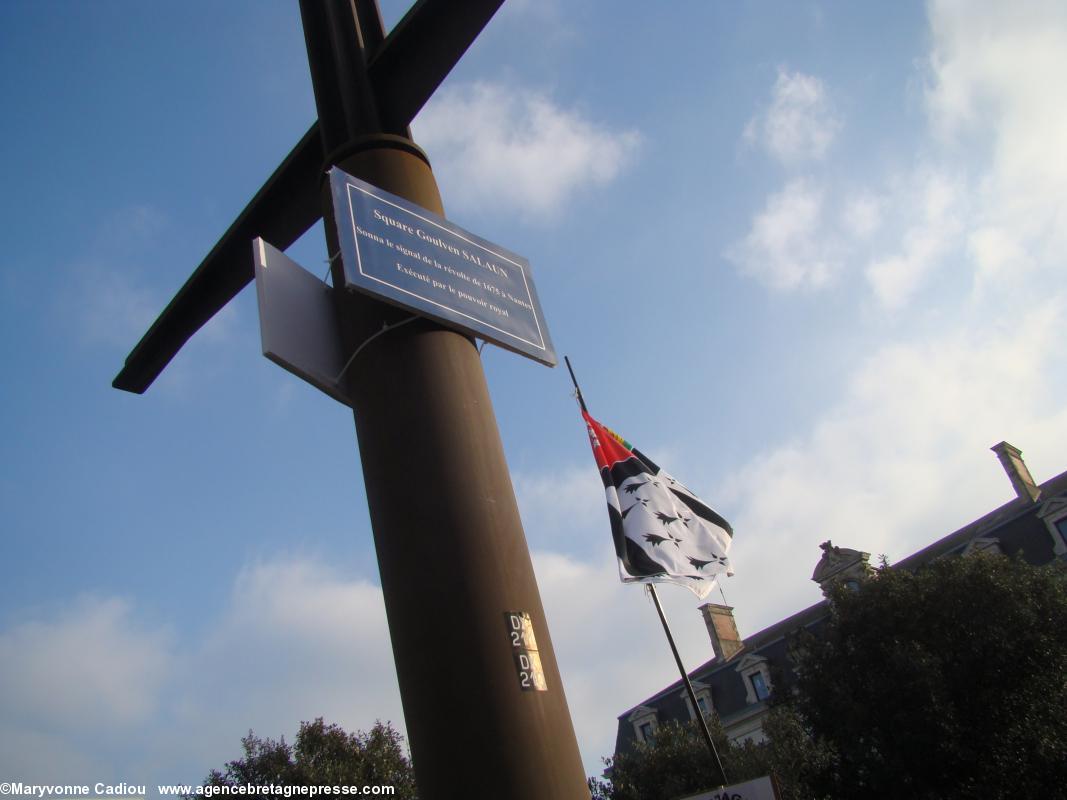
[{"xmin": 716, "ymin": 302, "xmax": 1067, "ymax": 627}]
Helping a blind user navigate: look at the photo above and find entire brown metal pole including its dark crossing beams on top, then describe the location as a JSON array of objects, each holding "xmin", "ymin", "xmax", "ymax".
[{"xmin": 114, "ymin": 0, "xmax": 589, "ymax": 800}]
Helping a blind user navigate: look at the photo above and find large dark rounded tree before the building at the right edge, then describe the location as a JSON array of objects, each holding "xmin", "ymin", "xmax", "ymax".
[{"xmin": 797, "ymin": 555, "xmax": 1067, "ymax": 800}]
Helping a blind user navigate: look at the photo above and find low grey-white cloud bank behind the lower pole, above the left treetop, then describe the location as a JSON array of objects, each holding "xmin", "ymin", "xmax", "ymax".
[{"xmin": 0, "ymin": 546, "xmax": 711, "ymax": 783}]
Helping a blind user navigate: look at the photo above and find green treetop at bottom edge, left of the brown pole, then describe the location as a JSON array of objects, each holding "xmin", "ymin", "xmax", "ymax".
[{"xmin": 195, "ymin": 717, "xmax": 418, "ymax": 800}]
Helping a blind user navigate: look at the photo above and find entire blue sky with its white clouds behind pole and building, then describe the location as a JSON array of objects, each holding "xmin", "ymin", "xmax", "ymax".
[{"xmin": 0, "ymin": 0, "xmax": 1067, "ymax": 784}]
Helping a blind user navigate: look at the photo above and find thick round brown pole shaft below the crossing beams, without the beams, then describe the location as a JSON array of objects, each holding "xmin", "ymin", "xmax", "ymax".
[{"xmin": 322, "ymin": 134, "xmax": 589, "ymax": 800}]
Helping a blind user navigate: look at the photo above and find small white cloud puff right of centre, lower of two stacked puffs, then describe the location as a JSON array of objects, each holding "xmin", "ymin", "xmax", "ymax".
[{"xmin": 727, "ymin": 178, "xmax": 840, "ymax": 290}]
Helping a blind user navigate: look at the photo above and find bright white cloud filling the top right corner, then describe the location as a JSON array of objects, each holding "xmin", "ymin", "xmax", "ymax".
[{"xmin": 926, "ymin": 0, "xmax": 1067, "ymax": 289}]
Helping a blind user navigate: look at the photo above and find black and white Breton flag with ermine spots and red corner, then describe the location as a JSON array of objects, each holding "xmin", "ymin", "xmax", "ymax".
[{"xmin": 582, "ymin": 409, "xmax": 733, "ymax": 599}]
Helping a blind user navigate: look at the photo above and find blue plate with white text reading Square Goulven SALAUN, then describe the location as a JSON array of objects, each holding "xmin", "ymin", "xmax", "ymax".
[{"xmin": 330, "ymin": 166, "xmax": 556, "ymax": 367}]
